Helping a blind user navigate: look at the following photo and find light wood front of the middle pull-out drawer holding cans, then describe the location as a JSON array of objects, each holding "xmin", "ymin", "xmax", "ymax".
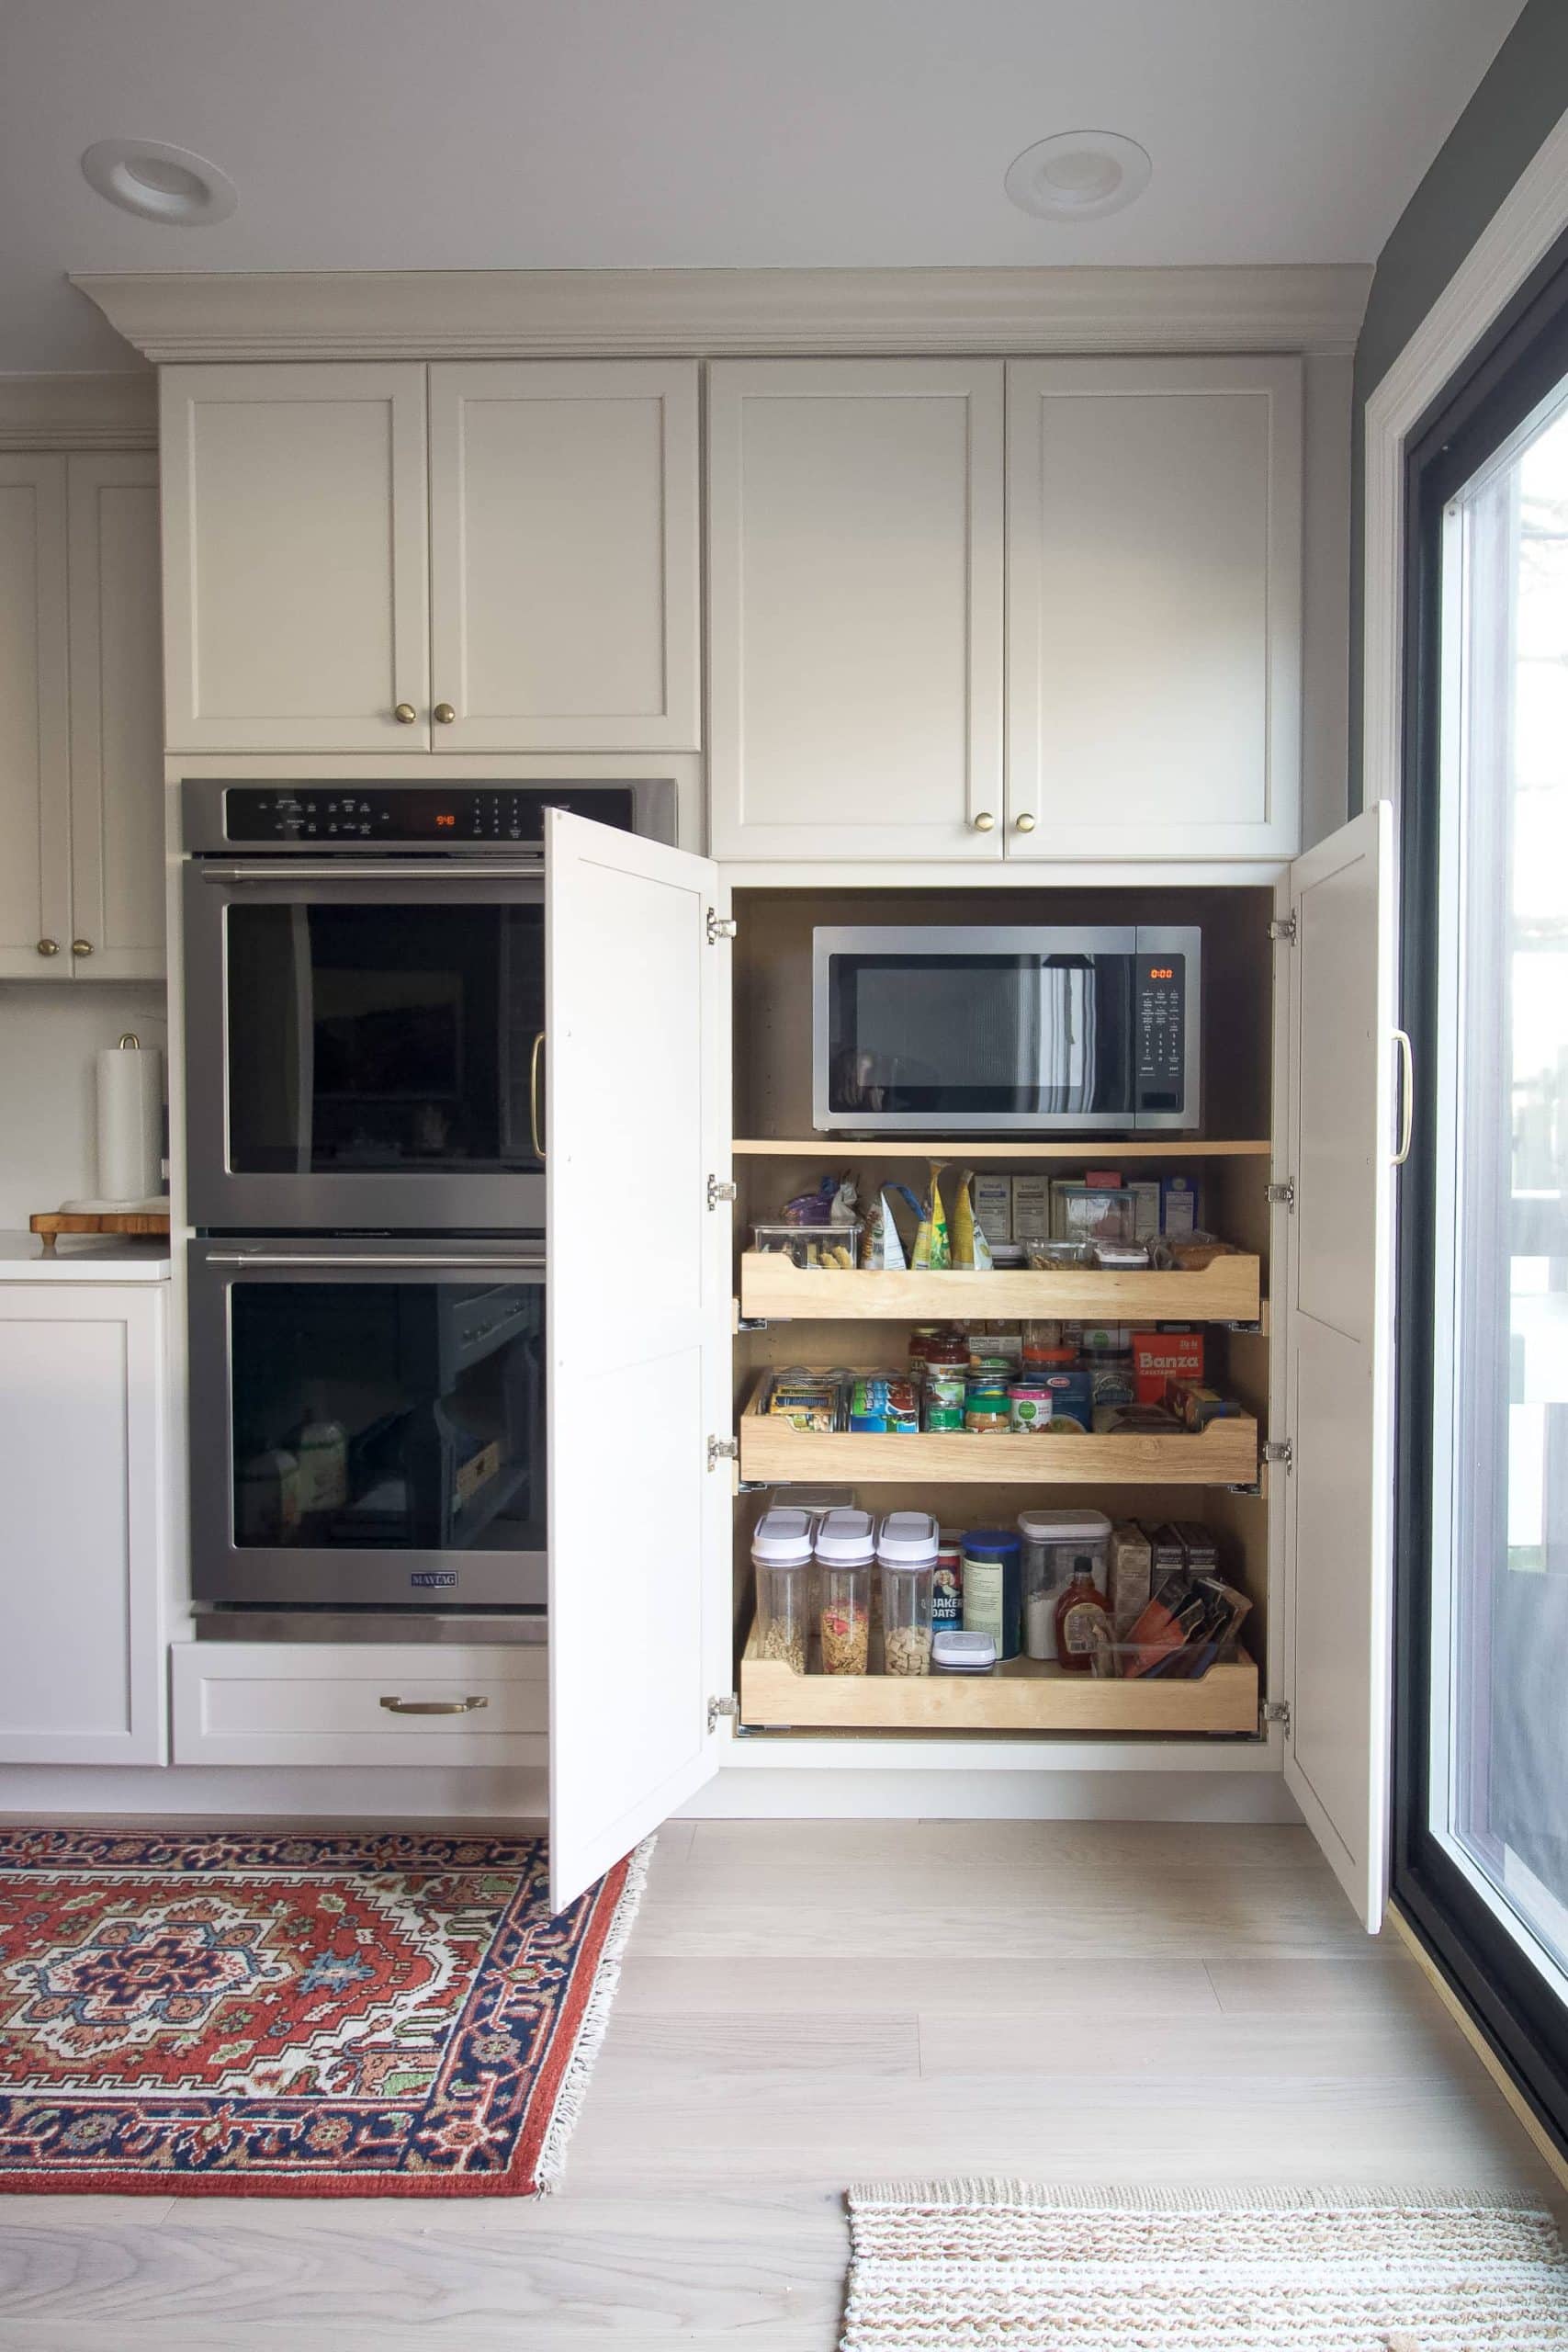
[{"xmin": 740, "ymin": 1374, "xmax": 1258, "ymax": 1486}]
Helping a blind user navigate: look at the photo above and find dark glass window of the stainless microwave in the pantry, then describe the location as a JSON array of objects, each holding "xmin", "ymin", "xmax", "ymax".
[{"xmin": 828, "ymin": 953, "xmax": 1143, "ymax": 1120}]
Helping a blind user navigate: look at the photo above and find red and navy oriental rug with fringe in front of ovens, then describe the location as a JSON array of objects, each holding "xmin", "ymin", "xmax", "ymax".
[{"xmin": 0, "ymin": 1830, "xmax": 651, "ymax": 2197}]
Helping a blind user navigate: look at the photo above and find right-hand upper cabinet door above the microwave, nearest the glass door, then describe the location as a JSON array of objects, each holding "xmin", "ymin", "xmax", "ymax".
[{"xmin": 1006, "ymin": 357, "xmax": 1303, "ymax": 858}]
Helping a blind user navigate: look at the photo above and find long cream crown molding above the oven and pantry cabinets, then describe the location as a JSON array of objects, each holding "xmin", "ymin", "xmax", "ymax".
[{"xmin": 71, "ymin": 264, "xmax": 1373, "ymax": 362}]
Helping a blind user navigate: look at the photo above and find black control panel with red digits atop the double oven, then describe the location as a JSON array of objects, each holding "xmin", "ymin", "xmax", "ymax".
[{"xmin": 223, "ymin": 783, "xmax": 637, "ymax": 849}]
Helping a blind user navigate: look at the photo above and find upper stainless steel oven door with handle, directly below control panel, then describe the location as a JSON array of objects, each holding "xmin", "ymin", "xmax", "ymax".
[{"xmin": 188, "ymin": 865, "xmax": 546, "ymax": 1230}]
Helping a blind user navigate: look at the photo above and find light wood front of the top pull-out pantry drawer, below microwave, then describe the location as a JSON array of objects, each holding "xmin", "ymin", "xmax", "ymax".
[{"xmin": 740, "ymin": 1249, "xmax": 1262, "ymax": 1326}]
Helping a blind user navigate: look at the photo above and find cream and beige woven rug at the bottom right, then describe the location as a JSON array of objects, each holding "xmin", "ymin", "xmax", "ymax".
[{"xmin": 844, "ymin": 2180, "xmax": 1568, "ymax": 2352}]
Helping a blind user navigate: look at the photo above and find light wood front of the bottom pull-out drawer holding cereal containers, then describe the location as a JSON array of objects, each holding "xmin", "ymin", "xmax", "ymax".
[{"xmin": 740, "ymin": 1627, "xmax": 1258, "ymax": 1738}]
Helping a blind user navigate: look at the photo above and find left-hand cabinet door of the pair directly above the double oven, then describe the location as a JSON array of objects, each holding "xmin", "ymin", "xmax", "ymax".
[{"xmin": 160, "ymin": 362, "xmax": 430, "ymax": 752}]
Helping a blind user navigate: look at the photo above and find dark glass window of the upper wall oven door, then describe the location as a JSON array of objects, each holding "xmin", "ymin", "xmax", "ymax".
[{"xmin": 226, "ymin": 903, "xmax": 543, "ymax": 1176}]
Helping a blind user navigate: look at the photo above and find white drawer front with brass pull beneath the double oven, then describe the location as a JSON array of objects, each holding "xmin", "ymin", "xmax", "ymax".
[{"xmin": 169, "ymin": 1642, "xmax": 547, "ymax": 1767}]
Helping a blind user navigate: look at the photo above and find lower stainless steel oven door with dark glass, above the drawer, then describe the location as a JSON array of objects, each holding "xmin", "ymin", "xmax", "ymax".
[{"xmin": 190, "ymin": 1239, "xmax": 546, "ymax": 1611}]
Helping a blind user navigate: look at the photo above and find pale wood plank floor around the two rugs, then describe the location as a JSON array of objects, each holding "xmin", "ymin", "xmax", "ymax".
[{"xmin": 0, "ymin": 1823, "xmax": 1551, "ymax": 2352}]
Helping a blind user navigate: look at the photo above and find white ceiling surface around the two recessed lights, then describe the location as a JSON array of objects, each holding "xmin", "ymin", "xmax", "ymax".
[{"xmin": 0, "ymin": 0, "xmax": 1521, "ymax": 369}]
